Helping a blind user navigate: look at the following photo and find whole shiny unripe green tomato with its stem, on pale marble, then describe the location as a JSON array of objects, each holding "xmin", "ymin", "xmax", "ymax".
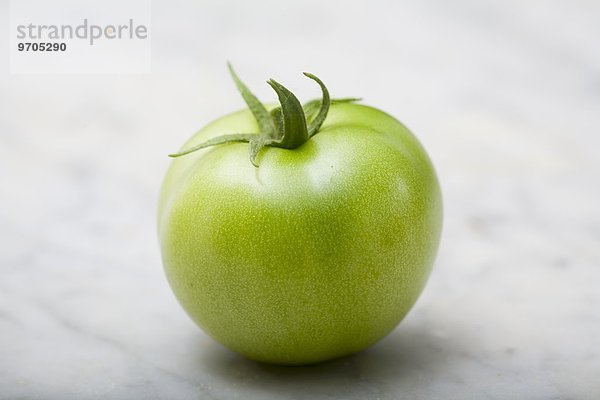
[{"xmin": 158, "ymin": 65, "xmax": 442, "ymax": 364}]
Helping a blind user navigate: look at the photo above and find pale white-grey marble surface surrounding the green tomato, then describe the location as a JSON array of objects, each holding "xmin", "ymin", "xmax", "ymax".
[{"xmin": 0, "ymin": 0, "xmax": 600, "ymax": 400}]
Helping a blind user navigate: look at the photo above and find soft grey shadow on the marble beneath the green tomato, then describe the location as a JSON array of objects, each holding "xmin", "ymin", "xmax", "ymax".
[{"xmin": 201, "ymin": 321, "xmax": 474, "ymax": 398}]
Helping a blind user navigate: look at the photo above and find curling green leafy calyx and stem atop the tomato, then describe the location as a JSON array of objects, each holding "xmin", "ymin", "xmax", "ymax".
[{"xmin": 169, "ymin": 64, "xmax": 359, "ymax": 167}]
